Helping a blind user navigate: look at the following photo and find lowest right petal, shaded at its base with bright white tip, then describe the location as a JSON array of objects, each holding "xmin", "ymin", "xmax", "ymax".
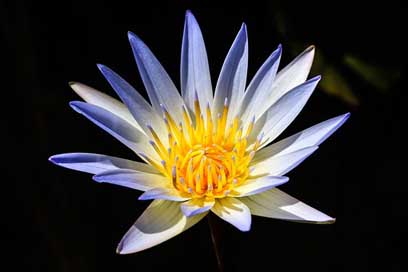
[{"xmin": 241, "ymin": 188, "xmax": 335, "ymax": 224}]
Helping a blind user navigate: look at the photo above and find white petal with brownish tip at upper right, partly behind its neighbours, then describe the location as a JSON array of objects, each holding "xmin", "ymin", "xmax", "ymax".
[{"xmin": 255, "ymin": 46, "xmax": 315, "ymax": 117}]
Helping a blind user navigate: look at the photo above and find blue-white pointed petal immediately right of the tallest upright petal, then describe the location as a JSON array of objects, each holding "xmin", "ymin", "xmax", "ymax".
[{"xmin": 213, "ymin": 24, "xmax": 248, "ymax": 127}]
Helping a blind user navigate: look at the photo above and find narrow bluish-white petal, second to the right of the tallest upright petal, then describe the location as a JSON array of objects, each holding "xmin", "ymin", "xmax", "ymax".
[{"xmin": 240, "ymin": 45, "xmax": 282, "ymax": 126}]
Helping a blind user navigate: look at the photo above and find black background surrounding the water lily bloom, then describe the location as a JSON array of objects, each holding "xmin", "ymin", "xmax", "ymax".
[{"xmin": 0, "ymin": 0, "xmax": 408, "ymax": 271}]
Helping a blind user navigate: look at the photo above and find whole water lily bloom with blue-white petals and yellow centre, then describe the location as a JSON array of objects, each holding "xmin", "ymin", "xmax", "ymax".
[{"xmin": 50, "ymin": 12, "xmax": 349, "ymax": 254}]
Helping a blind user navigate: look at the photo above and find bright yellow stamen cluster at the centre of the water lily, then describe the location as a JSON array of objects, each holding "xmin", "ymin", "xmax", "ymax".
[{"xmin": 145, "ymin": 97, "xmax": 261, "ymax": 198}]
